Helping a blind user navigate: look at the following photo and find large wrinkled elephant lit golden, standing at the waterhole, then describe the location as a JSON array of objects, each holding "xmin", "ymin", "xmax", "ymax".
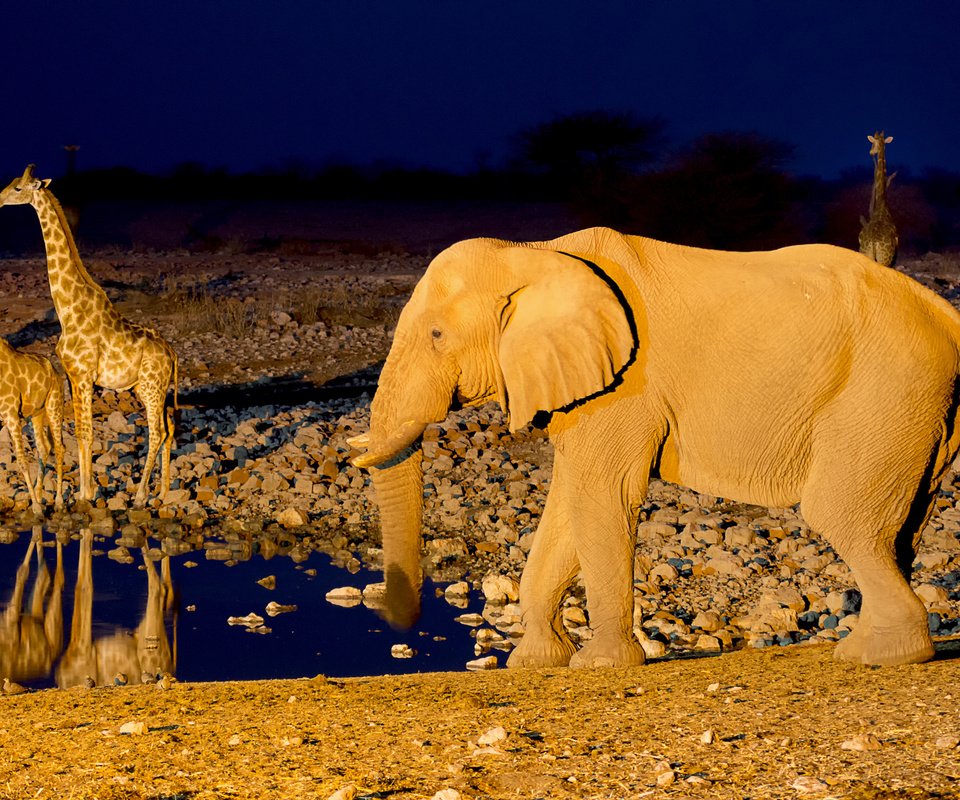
[{"xmin": 351, "ymin": 228, "xmax": 960, "ymax": 667}]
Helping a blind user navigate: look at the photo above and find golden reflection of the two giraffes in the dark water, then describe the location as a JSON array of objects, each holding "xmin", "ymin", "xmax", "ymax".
[{"xmin": 0, "ymin": 528, "xmax": 176, "ymax": 689}]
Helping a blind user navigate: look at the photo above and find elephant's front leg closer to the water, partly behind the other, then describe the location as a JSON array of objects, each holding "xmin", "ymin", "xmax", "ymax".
[{"xmin": 507, "ymin": 491, "xmax": 578, "ymax": 667}]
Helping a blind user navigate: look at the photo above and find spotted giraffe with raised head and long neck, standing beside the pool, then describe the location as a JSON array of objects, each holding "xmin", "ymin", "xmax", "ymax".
[{"xmin": 0, "ymin": 164, "xmax": 177, "ymax": 508}]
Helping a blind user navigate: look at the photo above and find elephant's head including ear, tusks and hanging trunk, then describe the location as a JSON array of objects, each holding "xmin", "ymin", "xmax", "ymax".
[{"xmin": 351, "ymin": 234, "xmax": 636, "ymax": 626}]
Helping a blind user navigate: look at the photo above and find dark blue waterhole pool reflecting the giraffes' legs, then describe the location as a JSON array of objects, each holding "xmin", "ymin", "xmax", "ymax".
[{"xmin": 0, "ymin": 531, "xmax": 488, "ymax": 688}]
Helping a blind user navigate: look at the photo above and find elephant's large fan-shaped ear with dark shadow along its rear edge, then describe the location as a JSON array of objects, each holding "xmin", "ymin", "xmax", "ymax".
[{"xmin": 499, "ymin": 248, "xmax": 636, "ymax": 431}]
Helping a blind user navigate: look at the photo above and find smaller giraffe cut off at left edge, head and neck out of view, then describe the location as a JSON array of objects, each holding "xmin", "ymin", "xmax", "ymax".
[{"xmin": 0, "ymin": 337, "xmax": 63, "ymax": 515}]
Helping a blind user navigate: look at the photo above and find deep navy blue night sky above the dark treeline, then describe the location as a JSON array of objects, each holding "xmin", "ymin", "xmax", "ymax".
[{"xmin": 0, "ymin": 0, "xmax": 960, "ymax": 182}]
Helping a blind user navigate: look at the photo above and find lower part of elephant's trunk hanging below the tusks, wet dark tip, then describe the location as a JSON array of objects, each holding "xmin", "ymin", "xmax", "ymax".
[{"xmin": 370, "ymin": 445, "xmax": 423, "ymax": 628}]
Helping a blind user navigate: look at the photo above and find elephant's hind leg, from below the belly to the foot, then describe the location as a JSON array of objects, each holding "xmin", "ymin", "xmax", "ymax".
[{"xmin": 801, "ymin": 438, "xmax": 940, "ymax": 665}]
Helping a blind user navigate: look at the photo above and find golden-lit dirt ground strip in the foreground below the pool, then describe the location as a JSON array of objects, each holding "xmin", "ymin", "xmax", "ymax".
[{"xmin": 0, "ymin": 641, "xmax": 960, "ymax": 800}]
